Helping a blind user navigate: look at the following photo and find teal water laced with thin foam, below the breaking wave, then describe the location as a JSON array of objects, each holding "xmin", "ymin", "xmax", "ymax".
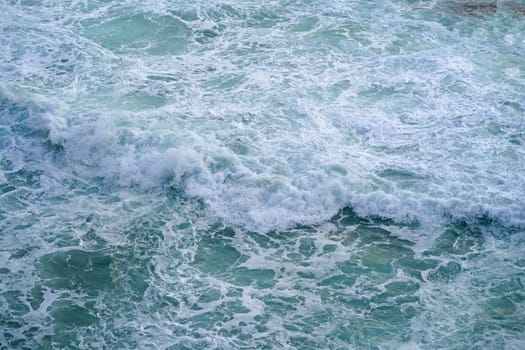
[{"xmin": 1, "ymin": 203, "xmax": 525, "ymax": 349}]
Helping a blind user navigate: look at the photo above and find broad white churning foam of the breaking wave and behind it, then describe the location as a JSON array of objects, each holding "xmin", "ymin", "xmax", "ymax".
[{"xmin": 2, "ymin": 0, "xmax": 525, "ymax": 231}]
